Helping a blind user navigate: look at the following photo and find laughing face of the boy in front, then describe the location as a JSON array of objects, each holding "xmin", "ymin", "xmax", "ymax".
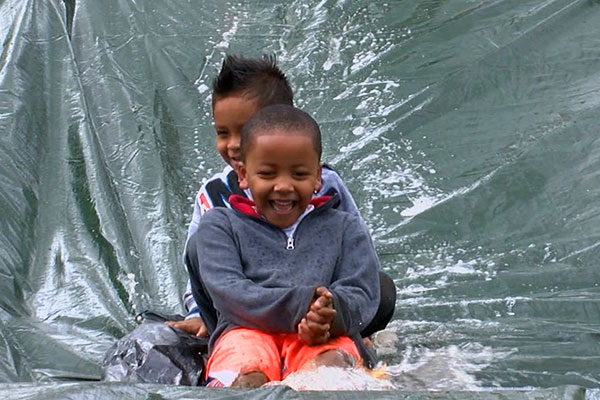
[{"xmin": 239, "ymin": 129, "xmax": 321, "ymax": 228}]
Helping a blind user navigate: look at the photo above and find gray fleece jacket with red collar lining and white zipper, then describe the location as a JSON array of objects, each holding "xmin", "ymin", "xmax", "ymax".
[{"xmin": 188, "ymin": 195, "xmax": 379, "ymax": 362}]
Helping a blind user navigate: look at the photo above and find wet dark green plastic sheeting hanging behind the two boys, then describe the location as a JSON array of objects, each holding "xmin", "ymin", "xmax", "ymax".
[{"xmin": 0, "ymin": 0, "xmax": 600, "ymax": 398}]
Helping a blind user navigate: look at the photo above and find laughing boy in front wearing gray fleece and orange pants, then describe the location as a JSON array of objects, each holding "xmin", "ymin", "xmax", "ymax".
[{"xmin": 186, "ymin": 105, "xmax": 380, "ymax": 387}]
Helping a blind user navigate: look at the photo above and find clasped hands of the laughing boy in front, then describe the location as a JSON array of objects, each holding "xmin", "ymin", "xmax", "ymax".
[{"xmin": 298, "ymin": 286, "xmax": 336, "ymax": 346}]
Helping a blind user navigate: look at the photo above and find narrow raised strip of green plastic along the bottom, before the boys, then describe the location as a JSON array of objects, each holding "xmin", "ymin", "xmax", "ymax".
[{"xmin": 0, "ymin": 383, "xmax": 586, "ymax": 400}]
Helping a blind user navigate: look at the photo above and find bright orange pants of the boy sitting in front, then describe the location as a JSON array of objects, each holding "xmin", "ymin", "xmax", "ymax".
[{"xmin": 206, "ymin": 328, "xmax": 360, "ymax": 386}]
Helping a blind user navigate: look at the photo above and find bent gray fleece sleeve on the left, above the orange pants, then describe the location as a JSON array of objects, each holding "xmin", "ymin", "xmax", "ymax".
[{"xmin": 190, "ymin": 209, "xmax": 315, "ymax": 333}]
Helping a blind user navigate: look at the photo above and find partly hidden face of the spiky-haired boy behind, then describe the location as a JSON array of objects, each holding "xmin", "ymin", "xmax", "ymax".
[{"xmin": 213, "ymin": 94, "xmax": 258, "ymax": 171}]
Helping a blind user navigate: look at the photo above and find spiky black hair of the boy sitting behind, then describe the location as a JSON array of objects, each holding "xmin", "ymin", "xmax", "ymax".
[{"xmin": 212, "ymin": 54, "xmax": 294, "ymax": 108}]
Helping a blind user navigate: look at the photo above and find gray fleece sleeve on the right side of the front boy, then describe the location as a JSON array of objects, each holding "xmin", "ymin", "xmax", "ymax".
[{"xmin": 329, "ymin": 216, "xmax": 380, "ymax": 336}]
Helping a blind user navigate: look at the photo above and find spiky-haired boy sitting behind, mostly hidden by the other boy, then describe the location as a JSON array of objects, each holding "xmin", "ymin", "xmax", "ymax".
[{"xmin": 169, "ymin": 56, "xmax": 396, "ymax": 337}]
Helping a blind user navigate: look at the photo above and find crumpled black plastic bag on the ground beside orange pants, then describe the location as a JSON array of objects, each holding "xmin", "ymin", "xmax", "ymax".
[{"xmin": 102, "ymin": 311, "xmax": 208, "ymax": 386}]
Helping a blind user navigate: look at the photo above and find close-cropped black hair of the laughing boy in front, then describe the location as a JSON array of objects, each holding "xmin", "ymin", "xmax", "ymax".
[{"xmin": 240, "ymin": 104, "xmax": 323, "ymax": 160}]
